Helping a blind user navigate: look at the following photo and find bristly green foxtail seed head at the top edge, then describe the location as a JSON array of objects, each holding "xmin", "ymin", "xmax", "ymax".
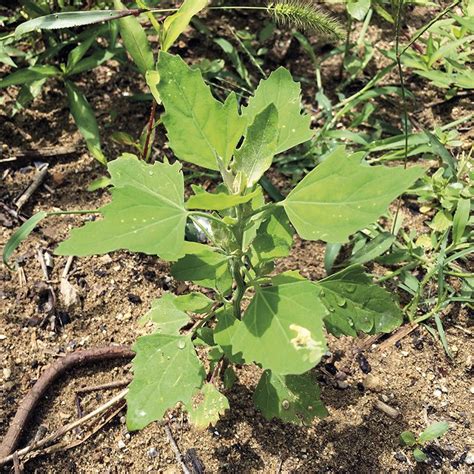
[{"xmin": 267, "ymin": 0, "xmax": 344, "ymax": 39}]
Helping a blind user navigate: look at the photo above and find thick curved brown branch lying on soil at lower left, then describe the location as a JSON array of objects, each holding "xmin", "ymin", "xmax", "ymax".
[{"xmin": 0, "ymin": 346, "xmax": 134, "ymax": 458}]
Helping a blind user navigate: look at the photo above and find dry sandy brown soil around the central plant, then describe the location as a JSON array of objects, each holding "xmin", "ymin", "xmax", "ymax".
[{"xmin": 0, "ymin": 4, "xmax": 474, "ymax": 473}]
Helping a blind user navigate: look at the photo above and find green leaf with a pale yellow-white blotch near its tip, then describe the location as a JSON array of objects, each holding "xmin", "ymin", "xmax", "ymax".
[{"xmin": 232, "ymin": 281, "xmax": 326, "ymax": 375}]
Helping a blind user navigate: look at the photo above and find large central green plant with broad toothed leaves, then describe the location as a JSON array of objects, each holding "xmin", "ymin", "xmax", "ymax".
[{"xmin": 4, "ymin": 52, "xmax": 423, "ymax": 430}]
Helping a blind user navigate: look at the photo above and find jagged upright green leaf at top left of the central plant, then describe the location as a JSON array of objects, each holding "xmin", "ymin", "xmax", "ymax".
[{"xmin": 157, "ymin": 52, "xmax": 245, "ymax": 170}]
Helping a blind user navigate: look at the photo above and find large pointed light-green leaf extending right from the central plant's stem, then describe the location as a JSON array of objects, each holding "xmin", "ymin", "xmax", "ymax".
[{"xmin": 279, "ymin": 147, "xmax": 423, "ymax": 243}]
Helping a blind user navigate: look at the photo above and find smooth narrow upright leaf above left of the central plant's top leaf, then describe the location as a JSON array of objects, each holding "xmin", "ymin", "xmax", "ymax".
[{"xmin": 114, "ymin": 0, "xmax": 155, "ymax": 76}]
